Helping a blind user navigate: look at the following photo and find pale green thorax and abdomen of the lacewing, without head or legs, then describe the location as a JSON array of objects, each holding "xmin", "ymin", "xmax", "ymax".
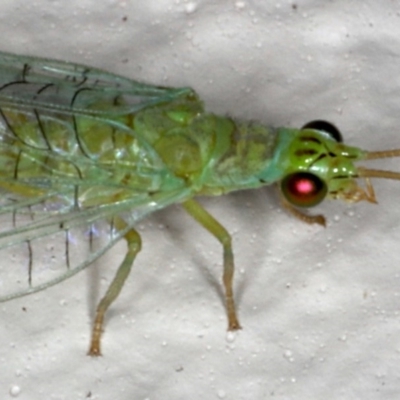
[{"xmin": 0, "ymin": 80, "xmax": 364, "ymax": 208}]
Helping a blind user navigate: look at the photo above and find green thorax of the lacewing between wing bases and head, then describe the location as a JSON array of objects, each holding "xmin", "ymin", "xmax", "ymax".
[{"xmin": 134, "ymin": 92, "xmax": 277, "ymax": 195}]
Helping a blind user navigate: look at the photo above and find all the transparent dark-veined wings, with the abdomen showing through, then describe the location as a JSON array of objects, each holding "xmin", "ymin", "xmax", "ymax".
[{"xmin": 0, "ymin": 52, "xmax": 190, "ymax": 301}]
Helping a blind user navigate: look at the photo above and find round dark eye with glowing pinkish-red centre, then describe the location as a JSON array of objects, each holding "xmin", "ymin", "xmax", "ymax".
[{"xmin": 281, "ymin": 172, "xmax": 328, "ymax": 207}]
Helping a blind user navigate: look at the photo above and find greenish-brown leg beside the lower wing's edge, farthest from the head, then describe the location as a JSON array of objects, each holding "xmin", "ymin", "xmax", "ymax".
[{"xmin": 88, "ymin": 217, "xmax": 142, "ymax": 356}]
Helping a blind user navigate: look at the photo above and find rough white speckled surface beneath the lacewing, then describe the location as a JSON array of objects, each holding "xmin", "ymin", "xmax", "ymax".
[{"xmin": 0, "ymin": 0, "xmax": 400, "ymax": 400}]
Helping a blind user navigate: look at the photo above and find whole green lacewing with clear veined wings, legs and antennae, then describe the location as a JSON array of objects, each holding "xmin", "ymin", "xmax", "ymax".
[{"xmin": 0, "ymin": 53, "xmax": 400, "ymax": 356}]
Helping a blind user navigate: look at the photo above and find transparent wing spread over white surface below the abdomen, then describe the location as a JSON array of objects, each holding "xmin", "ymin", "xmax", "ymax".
[{"xmin": 0, "ymin": 186, "xmax": 192, "ymax": 302}]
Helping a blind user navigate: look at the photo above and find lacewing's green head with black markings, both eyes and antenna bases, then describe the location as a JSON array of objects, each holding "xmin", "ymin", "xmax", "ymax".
[{"xmin": 280, "ymin": 121, "xmax": 400, "ymax": 207}]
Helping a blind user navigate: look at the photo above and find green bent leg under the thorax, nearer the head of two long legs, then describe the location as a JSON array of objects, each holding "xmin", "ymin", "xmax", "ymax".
[{"xmin": 182, "ymin": 199, "xmax": 241, "ymax": 331}]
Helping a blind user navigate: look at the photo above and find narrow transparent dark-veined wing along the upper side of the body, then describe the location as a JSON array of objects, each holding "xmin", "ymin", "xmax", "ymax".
[{"xmin": 0, "ymin": 52, "xmax": 192, "ymax": 117}]
